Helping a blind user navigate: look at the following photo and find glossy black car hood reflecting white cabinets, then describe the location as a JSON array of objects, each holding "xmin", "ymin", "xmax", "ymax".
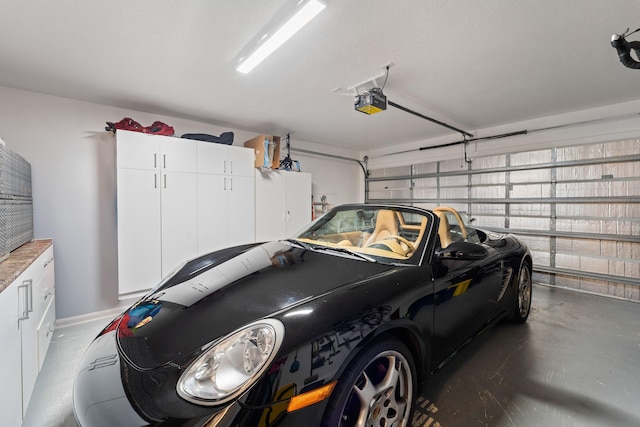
[{"xmin": 114, "ymin": 242, "xmax": 395, "ymax": 370}]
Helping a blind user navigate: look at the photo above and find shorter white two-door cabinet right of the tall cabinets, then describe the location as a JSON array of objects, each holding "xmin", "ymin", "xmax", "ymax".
[{"xmin": 255, "ymin": 169, "xmax": 311, "ymax": 242}]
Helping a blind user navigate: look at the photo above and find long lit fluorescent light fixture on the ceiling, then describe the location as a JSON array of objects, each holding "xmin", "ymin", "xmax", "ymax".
[{"xmin": 236, "ymin": 0, "xmax": 325, "ymax": 74}]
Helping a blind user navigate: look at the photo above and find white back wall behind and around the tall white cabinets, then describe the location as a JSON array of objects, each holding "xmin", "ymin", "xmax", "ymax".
[{"xmin": 0, "ymin": 86, "xmax": 364, "ymax": 318}]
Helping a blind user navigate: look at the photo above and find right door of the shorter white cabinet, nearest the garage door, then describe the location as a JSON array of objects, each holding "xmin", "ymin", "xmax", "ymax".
[{"xmin": 283, "ymin": 172, "xmax": 311, "ymax": 237}]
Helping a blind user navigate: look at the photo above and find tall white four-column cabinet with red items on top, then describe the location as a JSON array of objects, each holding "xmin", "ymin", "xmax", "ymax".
[{"xmin": 116, "ymin": 130, "xmax": 255, "ymax": 298}]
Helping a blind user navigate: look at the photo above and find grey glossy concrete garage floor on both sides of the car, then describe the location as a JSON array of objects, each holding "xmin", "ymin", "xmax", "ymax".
[{"xmin": 23, "ymin": 285, "xmax": 640, "ymax": 427}]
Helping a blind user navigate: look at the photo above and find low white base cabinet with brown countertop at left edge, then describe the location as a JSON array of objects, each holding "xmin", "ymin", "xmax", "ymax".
[{"xmin": 0, "ymin": 240, "xmax": 55, "ymax": 426}]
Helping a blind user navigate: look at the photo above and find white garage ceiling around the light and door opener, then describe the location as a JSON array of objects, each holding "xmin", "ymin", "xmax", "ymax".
[{"xmin": 0, "ymin": 0, "xmax": 640, "ymax": 151}]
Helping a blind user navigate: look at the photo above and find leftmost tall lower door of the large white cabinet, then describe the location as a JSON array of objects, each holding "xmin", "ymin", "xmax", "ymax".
[{"xmin": 118, "ymin": 169, "xmax": 162, "ymax": 298}]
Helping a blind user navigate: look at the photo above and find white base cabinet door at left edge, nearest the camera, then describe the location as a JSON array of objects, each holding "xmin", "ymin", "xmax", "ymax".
[{"xmin": 0, "ymin": 282, "xmax": 22, "ymax": 426}]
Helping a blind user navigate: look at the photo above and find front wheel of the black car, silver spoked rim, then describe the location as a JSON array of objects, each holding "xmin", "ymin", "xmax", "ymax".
[{"xmin": 322, "ymin": 337, "xmax": 417, "ymax": 427}]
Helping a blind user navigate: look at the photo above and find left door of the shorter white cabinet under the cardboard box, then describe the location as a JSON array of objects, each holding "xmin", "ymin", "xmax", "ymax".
[{"xmin": 255, "ymin": 169, "xmax": 287, "ymax": 242}]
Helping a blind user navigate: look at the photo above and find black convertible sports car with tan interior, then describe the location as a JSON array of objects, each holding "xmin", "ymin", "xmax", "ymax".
[{"xmin": 73, "ymin": 204, "xmax": 532, "ymax": 427}]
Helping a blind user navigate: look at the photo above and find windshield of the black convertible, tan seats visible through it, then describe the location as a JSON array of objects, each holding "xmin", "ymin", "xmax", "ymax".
[{"xmin": 294, "ymin": 205, "xmax": 429, "ymax": 263}]
